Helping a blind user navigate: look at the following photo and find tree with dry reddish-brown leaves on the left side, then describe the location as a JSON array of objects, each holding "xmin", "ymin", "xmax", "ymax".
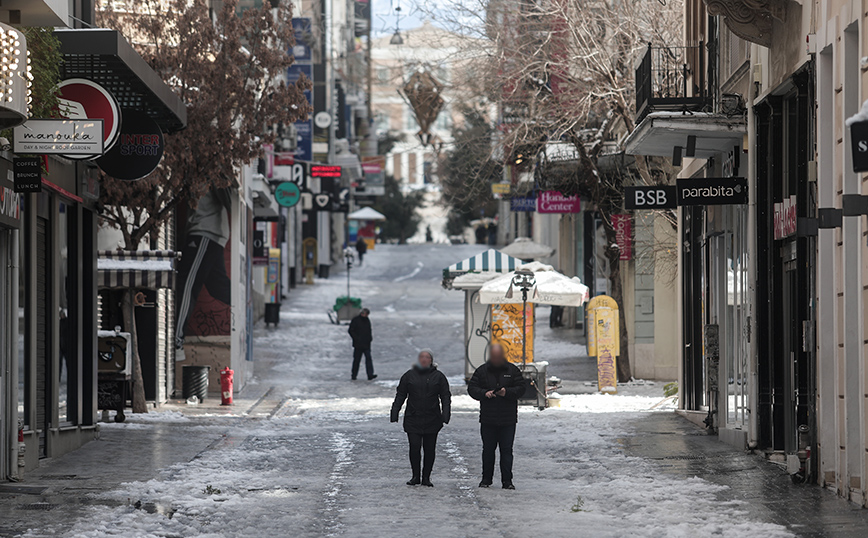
[{"xmin": 98, "ymin": 0, "xmax": 310, "ymax": 413}]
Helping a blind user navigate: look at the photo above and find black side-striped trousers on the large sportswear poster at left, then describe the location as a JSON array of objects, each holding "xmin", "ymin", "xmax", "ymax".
[{"xmin": 175, "ymin": 235, "xmax": 232, "ymax": 347}]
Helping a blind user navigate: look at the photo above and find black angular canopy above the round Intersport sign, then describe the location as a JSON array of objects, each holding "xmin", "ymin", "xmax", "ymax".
[{"xmin": 54, "ymin": 28, "xmax": 187, "ymax": 133}]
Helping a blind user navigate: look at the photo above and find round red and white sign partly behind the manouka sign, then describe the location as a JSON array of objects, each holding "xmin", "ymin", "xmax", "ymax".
[{"xmin": 57, "ymin": 78, "xmax": 121, "ymax": 159}]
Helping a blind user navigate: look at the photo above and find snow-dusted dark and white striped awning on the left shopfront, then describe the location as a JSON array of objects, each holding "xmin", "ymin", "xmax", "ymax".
[{"xmin": 96, "ymin": 250, "xmax": 177, "ymax": 290}]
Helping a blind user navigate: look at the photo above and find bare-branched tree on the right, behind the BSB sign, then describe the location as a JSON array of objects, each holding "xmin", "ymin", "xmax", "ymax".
[{"xmin": 420, "ymin": 0, "xmax": 682, "ymax": 381}]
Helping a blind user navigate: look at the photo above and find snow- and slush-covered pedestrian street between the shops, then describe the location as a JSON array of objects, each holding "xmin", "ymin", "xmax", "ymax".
[{"xmin": 0, "ymin": 244, "xmax": 868, "ymax": 538}]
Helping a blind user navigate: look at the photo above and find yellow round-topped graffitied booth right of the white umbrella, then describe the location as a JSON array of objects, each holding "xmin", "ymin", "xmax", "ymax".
[{"xmin": 588, "ymin": 295, "xmax": 621, "ymax": 394}]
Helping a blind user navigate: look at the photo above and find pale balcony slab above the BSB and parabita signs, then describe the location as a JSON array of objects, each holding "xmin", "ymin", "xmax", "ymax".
[{"xmin": 624, "ymin": 112, "xmax": 747, "ymax": 159}]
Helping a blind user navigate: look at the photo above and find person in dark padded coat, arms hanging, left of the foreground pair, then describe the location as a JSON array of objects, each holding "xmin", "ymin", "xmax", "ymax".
[{"xmin": 391, "ymin": 349, "xmax": 452, "ymax": 487}]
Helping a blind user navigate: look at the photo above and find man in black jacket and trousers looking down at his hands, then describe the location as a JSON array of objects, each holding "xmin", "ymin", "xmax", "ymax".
[{"xmin": 467, "ymin": 344, "xmax": 527, "ymax": 489}]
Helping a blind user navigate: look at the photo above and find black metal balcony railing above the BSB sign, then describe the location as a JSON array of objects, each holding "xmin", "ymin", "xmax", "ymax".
[{"xmin": 636, "ymin": 41, "xmax": 709, "ymax": 123}]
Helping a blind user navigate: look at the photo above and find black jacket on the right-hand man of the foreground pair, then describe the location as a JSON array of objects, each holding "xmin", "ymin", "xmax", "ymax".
[{"xmin": 467, "ymin": 362, "xmax": 527, "ymax": 426}]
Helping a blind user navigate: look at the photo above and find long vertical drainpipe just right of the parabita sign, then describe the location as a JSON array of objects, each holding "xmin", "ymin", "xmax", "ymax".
[{"xmin": 747, "ymin": 44, "xmax": 759, "ymax": 450}]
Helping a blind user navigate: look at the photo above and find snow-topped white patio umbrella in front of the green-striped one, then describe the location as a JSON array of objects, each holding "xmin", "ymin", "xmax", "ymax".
[{"xmin": 479, "ymin": 262, "xmax": 589, "ymax": 306}]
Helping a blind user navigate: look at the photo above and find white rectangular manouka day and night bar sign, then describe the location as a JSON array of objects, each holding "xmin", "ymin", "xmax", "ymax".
[{"xmin": 12, "ymin": 119, "xmax": 105, "ymax": 155}]
